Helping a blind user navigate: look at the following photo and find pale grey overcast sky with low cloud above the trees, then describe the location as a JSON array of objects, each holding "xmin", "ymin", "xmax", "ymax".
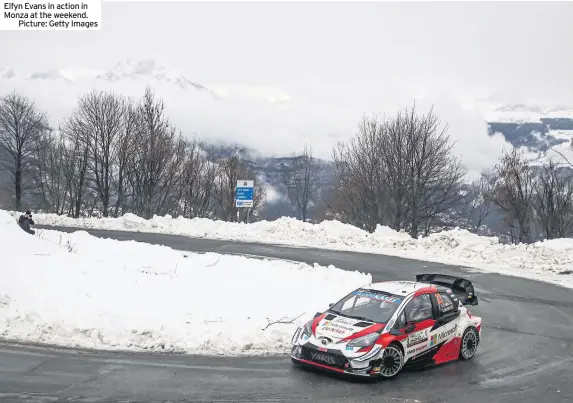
[{"xmin": 0, "ymin": 2, "xmax": 573, "ymax": 178}]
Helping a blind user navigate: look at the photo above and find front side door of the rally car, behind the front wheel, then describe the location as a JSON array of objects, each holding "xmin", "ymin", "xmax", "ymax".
[{"xmin": 398, "ymin": 294, "xmax": 435, "ymax": 359}]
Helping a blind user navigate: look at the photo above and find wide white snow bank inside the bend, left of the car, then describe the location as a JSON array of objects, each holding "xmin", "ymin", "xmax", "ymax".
[{"xmin": 0, "ymin": 211, "xmax": 372, "ymax": 355}]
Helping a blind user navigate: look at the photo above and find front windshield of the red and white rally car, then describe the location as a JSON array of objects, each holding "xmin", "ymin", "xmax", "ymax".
[{"xmin": 330, "ymin": 288, "xmax": 402, "ymax": 323}]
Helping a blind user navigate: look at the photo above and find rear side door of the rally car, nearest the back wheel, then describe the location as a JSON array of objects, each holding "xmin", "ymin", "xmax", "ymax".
[{"xmin": 429, "ymin": 290, "xmax": 460, "ymax": 347}]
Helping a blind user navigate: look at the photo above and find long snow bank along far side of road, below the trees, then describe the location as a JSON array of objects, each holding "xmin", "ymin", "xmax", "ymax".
[{"xmin": 7, "ymin": 213, "xmax": 573, "ymax": 288}]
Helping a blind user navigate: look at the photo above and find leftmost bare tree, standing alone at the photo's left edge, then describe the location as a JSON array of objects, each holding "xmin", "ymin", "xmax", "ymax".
[{"xmin": 0, "ymin": 91, "xmax": 48, "ymax": 210}]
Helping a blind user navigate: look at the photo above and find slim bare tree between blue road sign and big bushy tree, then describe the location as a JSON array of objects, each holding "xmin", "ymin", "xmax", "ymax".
[{"xmin": 282, "ymin": 144, "xmax": 317, "ymax": 221}]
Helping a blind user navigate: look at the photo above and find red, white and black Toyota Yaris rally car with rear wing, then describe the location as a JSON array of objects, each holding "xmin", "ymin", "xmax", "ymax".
[{"xmin": 291, "ymin": 274, "xmax": 482, "ymax": 378}]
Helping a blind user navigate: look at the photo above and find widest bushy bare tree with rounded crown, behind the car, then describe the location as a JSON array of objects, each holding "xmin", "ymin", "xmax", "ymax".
[{"xmin": 334, "ymin": 108, "xmax": 466, "ymax": 237}]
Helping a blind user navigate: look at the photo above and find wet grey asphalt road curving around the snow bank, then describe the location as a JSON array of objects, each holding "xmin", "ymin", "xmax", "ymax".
[{"xmin": 0, "ymin": 228, "xmax": 573, "ymax": 403}]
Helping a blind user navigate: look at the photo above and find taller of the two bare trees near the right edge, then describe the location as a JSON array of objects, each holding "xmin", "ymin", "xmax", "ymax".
[{"xmin": 486, "ymin": 149, "xmax": 535, "ymax": 243}]
